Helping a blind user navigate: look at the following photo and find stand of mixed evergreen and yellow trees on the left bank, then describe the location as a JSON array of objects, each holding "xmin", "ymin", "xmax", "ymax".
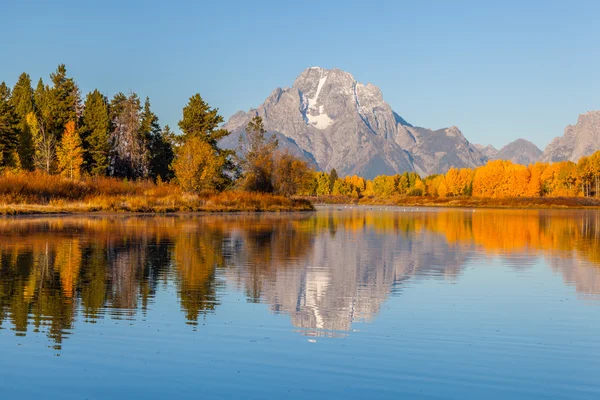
[{"xmin": 0, "ymin": 64, "xmax": 309, "ymax": 195}]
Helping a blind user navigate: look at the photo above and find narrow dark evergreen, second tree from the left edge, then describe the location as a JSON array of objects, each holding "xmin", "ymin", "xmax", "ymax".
[{"xmin": 11, "ymin": 72, "xmax": 34, "ymax": 171}]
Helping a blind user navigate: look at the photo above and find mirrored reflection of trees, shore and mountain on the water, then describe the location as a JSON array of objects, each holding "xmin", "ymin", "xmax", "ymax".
[{"xmin": 0, "ymin": 209, "xmax": 600, "ymax": 349}]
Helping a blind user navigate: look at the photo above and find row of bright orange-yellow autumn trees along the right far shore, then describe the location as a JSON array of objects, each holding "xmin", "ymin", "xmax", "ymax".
[{"xmin": 298, "ymin": 151, "xmax": 600, "ymax": 198}]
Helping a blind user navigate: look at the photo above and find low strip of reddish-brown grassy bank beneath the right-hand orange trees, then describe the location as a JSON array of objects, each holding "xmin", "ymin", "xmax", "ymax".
[{"xmin": 302, "ymin": 196, "xmax": 600, "ymax": 209}]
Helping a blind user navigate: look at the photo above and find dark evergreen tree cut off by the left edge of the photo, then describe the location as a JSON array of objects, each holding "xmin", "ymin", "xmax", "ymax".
[{"xmin": 0, "ymin": 82, "xmax": 19, "ymax": 170}]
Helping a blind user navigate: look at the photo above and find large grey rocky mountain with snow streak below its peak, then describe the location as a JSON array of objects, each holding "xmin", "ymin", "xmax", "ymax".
[{"xmin": 221, "ymin": 67, "xmax": 486, "ymax": 178}]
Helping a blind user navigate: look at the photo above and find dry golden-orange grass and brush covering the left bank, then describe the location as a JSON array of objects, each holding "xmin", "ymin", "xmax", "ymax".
[{"xmin": 0, "ymin": 172, "xmax": 314, "ymax": 214}]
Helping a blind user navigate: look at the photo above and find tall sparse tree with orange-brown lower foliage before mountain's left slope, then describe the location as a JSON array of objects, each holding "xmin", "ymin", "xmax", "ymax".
[{"xmin": 239, "ymin": 115, "xmax": 278, "ymax": 193}]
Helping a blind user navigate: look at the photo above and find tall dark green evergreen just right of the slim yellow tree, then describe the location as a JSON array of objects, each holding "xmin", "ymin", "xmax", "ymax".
[{"xmin": 81, "ymin": 89, "xmax": 110, "ymax": 176}]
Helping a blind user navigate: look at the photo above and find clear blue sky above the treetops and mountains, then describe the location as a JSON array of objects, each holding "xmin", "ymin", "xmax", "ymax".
[{"xmin": 0, "ymin": 0, "xmax": 600, "ymax": 147}]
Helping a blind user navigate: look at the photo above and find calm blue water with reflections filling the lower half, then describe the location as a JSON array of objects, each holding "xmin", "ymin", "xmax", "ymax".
[{"xmin": 0, "ymin": 208, "xmax": 600, "ymax": 399}]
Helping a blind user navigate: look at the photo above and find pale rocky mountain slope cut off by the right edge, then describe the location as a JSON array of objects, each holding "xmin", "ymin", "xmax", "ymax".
[{"xmin": 540, "ymin": 111, "xmax": 600, "ymax": 162}]
